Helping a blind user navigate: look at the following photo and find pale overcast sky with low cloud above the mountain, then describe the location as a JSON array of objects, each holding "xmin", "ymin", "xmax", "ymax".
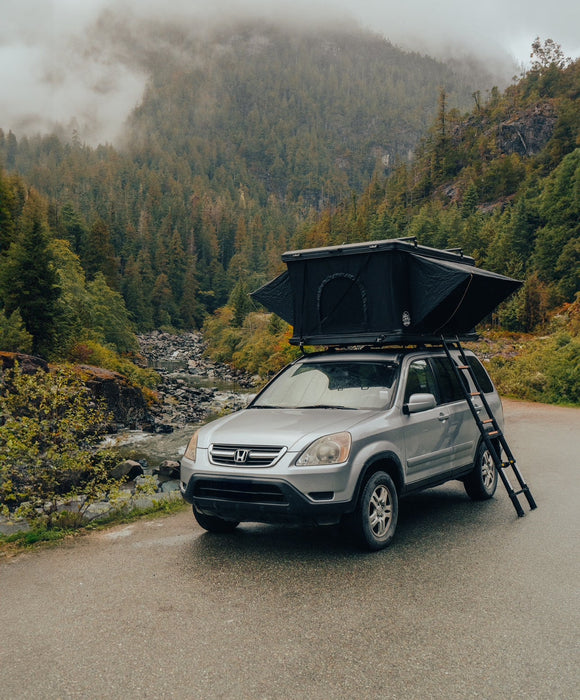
[{"xmin": 0, "ymin": 0, "xmax": 580, "ymax": 143}]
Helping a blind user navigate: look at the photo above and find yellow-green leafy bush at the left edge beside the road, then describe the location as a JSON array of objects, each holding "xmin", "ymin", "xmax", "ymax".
[{"xmin": 0, "ymin": 365, "xmax": 119, "ymax": 527}]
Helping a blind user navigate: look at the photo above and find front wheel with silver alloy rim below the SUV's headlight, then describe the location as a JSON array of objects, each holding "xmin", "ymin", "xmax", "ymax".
[{"xmin": 349, "ymin": 472, "xmax": 399, "ymax": 551}]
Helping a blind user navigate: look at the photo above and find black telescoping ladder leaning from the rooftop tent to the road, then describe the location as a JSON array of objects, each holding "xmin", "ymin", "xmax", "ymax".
[{"xmin": 442, "ymin": 338, "xmax": 537, "ymax": 518}]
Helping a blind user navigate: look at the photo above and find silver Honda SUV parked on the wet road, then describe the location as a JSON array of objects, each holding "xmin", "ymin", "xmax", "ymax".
[{"xmin": 181, "ymin": 347, "xmax": 503, "ymax": 550}]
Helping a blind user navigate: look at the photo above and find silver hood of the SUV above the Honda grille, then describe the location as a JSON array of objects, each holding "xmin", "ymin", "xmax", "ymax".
[{"xmin": 198, "ymin": 408, "xmax": 374, "ymax": 452}]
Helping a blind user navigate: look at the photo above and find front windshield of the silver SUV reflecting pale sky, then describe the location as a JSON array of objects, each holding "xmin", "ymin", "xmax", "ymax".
[{"xmin": 251, "ymin": 360, "xmax": 397, "ymax": 410}]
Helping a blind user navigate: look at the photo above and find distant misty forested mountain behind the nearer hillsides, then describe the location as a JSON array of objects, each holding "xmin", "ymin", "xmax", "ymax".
[{"xmin": 0, "ymin": 24, "xmax": 492, "ymax": 329}]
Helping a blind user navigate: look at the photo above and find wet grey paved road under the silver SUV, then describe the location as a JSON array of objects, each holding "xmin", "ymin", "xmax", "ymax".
[{"xmin": 0, "ymin": 402, "xmax": 580, "ymax": 700}]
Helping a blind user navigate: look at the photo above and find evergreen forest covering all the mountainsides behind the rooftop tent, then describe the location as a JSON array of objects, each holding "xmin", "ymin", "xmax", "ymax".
[{"xmin": 0, "ymin": 24, "xmax": 580, "ymax": 401}]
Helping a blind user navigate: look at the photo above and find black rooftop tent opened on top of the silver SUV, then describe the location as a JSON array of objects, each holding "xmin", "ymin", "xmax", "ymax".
[{"xmin": 252, "ymin": 239, "xmax": 521, "ymax": 345}]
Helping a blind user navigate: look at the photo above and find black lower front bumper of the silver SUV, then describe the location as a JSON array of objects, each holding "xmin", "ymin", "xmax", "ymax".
[{"xmin": 182, "ymin": 474, "xmax": 352, "ymax": 525}]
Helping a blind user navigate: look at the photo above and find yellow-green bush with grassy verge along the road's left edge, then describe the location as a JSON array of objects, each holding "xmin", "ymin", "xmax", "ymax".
[{"xmin": 0, "ymin": 364, "xmax": 182, "ymax": 551}]
